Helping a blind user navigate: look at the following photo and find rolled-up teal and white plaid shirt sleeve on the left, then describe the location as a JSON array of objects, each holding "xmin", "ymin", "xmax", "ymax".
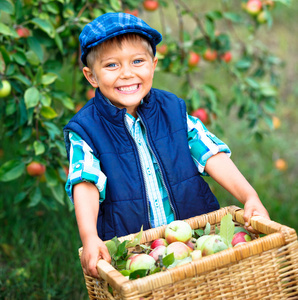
[{"xmin": 65, "ymin": 131, "xmax": 107, "ymax": 203}]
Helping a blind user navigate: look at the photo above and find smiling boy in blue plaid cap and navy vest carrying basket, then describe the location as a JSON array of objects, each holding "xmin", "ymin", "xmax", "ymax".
[{"xmin": 64, "ymin": 13, "xmax": 269, "ymax": 277}]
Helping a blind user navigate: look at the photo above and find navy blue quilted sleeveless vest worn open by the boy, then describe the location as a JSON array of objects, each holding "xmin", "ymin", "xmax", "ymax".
[{"xmin": 64, "ymin": 89, "xmax": 219, "ymax": 240}]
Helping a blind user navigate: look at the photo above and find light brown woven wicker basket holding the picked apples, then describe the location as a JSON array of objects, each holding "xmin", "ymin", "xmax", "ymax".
[{"xmin": 79, "ymin": 206, "xmax": 298, "ymax": 300}]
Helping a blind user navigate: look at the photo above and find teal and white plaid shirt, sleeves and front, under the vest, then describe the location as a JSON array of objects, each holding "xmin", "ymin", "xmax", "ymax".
[{"xmin": 65, "ymin": 113, "xmax": 231, "ymax": 227}]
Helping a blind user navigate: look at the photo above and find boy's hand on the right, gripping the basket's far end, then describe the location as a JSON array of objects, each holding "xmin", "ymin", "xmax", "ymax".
[{"xmin": 243, "ymin": 197, "xmax": 270, "ymax": 233}]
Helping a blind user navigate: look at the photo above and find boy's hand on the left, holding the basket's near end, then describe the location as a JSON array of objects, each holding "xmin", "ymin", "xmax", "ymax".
[{"xmin": 81, "ymin": 236, "xmax": 111, "ymax": 277}]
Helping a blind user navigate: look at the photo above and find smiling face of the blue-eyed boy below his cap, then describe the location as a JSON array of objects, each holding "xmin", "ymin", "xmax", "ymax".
[{"xmin": 83, "ymin": 40, "xmax": 157, "ymax": 117}]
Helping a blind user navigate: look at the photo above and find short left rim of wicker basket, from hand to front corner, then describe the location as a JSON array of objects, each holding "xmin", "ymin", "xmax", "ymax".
[{"xmin": 96, "ymin": 259, "xmax": 129, "ymax": 290}]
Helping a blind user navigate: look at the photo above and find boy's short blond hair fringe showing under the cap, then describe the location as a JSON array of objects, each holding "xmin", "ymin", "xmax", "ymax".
[{"xmin": 86, "ymin": 33, "xmax": 154, "ymax": 70}]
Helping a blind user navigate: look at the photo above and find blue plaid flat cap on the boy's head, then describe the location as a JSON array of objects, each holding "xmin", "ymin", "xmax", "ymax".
[{"xmin": 79, "ymin": 13, "xmax": 162, "ymax": 66}]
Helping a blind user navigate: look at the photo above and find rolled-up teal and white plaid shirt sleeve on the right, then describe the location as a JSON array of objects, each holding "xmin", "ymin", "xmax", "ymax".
[{"xmin": 187, "ymin": 115, "xmax": 231, "ymax": 175}]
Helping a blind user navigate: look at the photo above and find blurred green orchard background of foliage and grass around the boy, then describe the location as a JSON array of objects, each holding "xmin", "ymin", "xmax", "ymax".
[{"xmin": 0, "ymin": 0, "xmax": 298, "ymax": 299}]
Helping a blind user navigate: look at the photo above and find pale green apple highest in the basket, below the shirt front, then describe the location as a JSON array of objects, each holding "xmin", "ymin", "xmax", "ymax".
[{"xmin": 165, "ymin": 220, "xmax": 192, "ymax": 244}]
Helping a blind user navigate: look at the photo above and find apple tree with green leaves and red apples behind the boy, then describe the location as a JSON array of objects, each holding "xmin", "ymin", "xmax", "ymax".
[{"xmin": 0, "ymin": 0, "xmax": 290, "ymax": 209}]
